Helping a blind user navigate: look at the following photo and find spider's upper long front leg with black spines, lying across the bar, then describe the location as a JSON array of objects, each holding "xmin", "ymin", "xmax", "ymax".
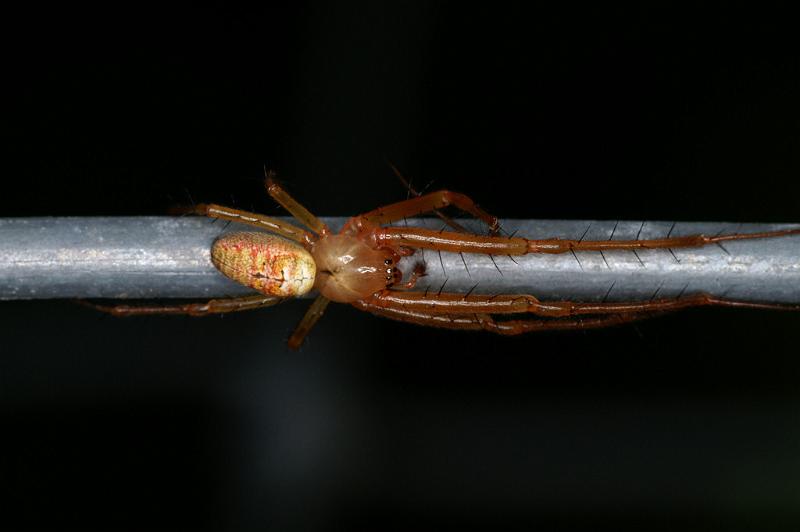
[{"xmin": 372, "ymin": 225, "xmax": 800, "ymax": 255}]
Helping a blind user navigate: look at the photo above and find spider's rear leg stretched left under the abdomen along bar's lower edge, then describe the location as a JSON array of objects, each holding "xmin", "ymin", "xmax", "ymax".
[{"xmin": 79, "ymin": 294, "xmax": 283, "ymax": 317}]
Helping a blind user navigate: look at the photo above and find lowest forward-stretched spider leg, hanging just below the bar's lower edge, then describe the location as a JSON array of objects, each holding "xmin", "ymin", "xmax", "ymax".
[{"xmin": 353, "ymin": 301, "xmax": 659, "ymax": 336}]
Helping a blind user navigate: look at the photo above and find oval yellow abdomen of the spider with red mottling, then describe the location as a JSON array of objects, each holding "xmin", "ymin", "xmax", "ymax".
[{"xmin": 211, "ymin": 233, "xmax": 317, "ymax": 297}]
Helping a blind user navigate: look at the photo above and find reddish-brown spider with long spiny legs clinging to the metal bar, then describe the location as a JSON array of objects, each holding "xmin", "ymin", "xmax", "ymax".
[{"xmin": 89, "ymin": 174, "xmax": 800, "ymax": 349}]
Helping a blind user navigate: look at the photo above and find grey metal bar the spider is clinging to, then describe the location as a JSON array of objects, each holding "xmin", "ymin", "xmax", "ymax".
[{"xmin": 0, "ymin": 217, "xmax": 800, "ymax": 303}]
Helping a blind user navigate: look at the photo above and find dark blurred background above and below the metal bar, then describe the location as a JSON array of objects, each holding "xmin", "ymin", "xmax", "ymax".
[{"xmin": 0, "ymin": 2, "xmax": 800, "ymax": 530}]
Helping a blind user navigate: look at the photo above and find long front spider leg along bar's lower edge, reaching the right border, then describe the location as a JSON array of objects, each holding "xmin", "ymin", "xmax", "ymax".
[{"xmin": 364, "ymin": 290, "xmax": 800, "ymax": 318}]
